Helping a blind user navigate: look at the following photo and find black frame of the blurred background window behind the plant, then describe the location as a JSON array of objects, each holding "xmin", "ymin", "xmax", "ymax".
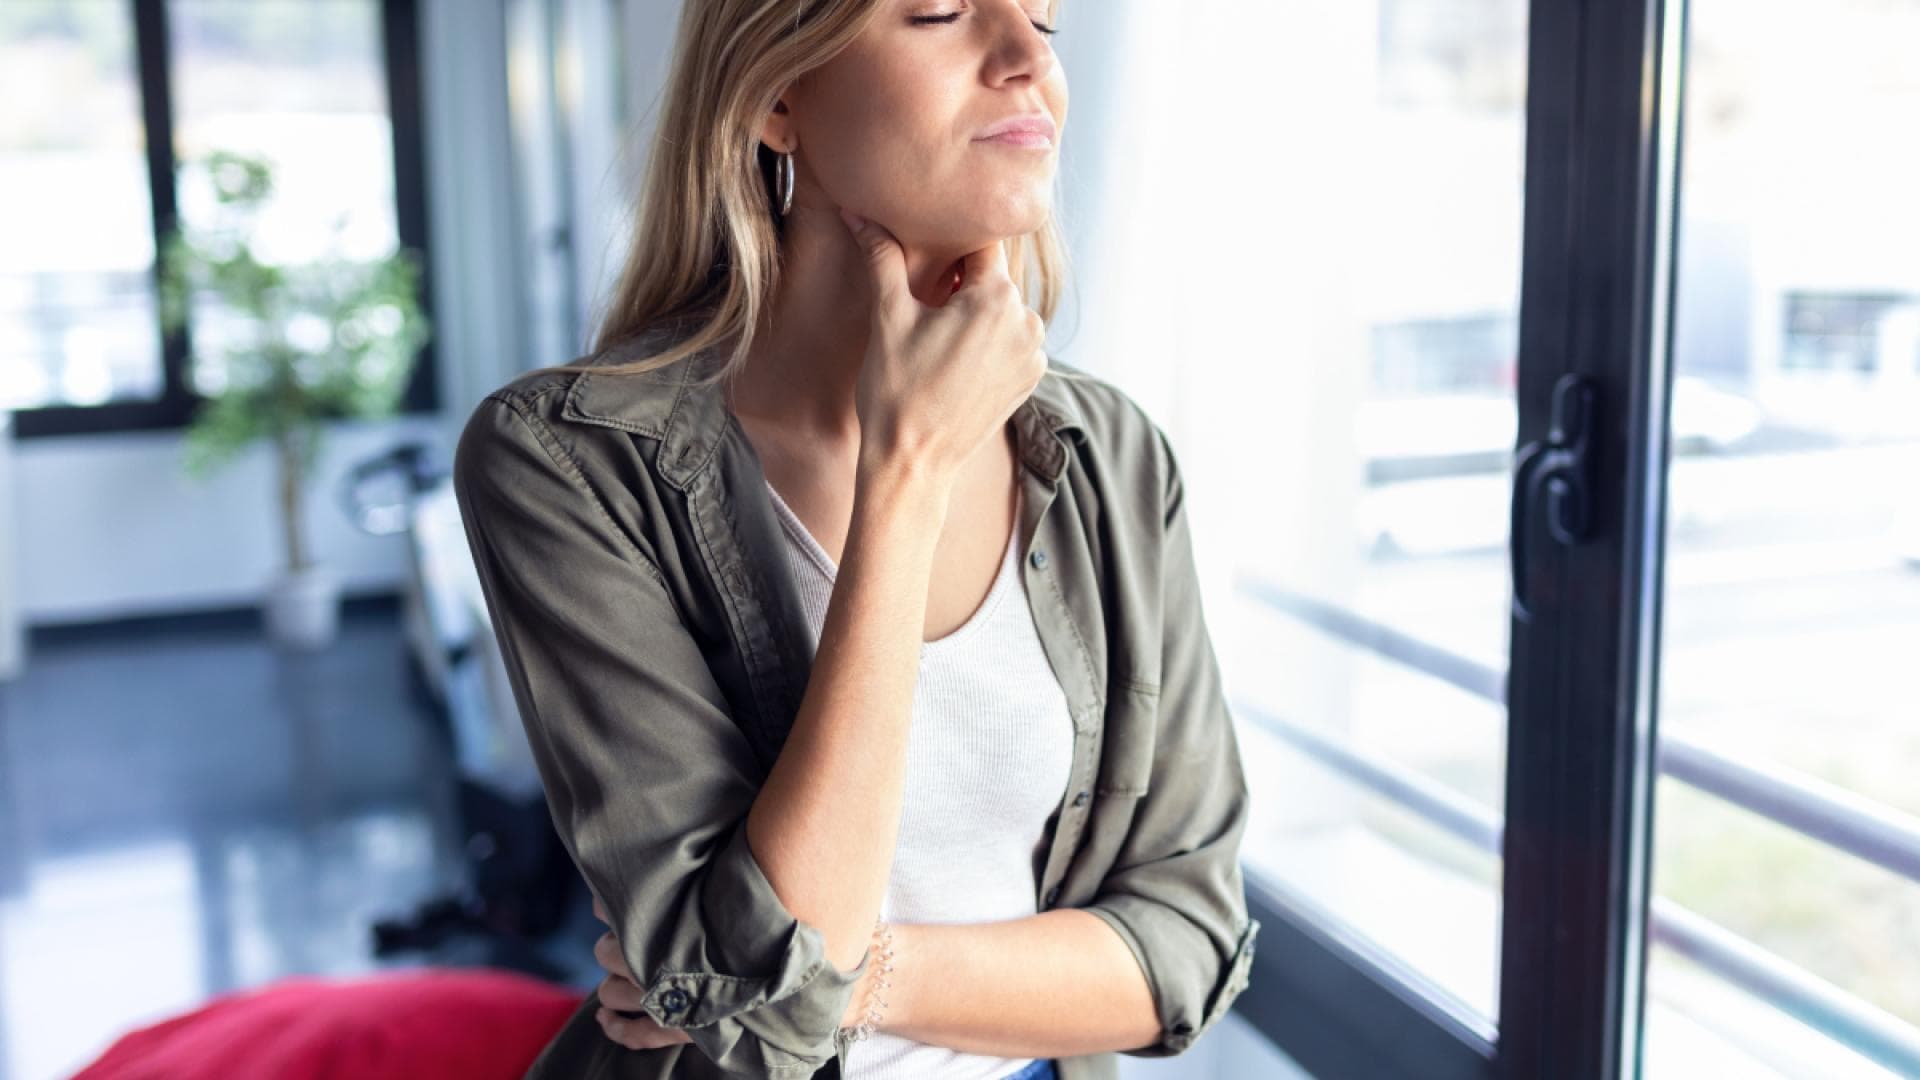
[{"xmin": 13, "ymin": 0, "xmax": 440, "ymax": 438}]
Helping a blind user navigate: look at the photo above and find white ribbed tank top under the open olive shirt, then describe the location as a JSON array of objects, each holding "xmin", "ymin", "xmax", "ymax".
[{"xmin": 766, "ymin": 484, "xmax": 1073, "ymax": 1080}]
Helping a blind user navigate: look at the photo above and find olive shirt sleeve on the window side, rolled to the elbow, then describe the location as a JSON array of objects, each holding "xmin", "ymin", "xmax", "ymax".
[{"xmin": 1085, "ymin": 427, "xmax": 1260, "ymax": 1057}]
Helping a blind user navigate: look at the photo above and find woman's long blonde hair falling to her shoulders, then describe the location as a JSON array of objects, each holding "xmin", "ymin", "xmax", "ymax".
[{"xmin": 540, "ymin": 0, "xmax": 1090, "ymax": 380}]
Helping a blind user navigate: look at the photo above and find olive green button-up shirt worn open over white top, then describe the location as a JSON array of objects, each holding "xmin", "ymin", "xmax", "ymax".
[{"xmin": 453, "ymin": 320, "xmax": 1260, "ymax": 1080}]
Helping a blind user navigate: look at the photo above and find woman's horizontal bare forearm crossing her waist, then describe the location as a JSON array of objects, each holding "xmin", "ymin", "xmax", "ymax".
[{"xmin": 879, "ymin": 907, "xmax": 1160, "ymax": 1057}]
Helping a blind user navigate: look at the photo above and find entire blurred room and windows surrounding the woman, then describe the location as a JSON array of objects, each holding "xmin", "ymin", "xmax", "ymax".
[{"xmin": 0, "ymin": 0, "xmax": 1920, "ymax": 1080}]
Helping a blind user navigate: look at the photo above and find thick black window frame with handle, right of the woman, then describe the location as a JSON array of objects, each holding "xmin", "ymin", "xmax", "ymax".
[{"xmin": 1236, "ymin": 0, "xmax": 1684, "ymax": 1080}]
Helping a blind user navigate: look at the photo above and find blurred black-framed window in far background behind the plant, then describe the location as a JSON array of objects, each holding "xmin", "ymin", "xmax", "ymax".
[{"xmin": 0, "ymin": 0, "xmax": 438, "ymax": 436}]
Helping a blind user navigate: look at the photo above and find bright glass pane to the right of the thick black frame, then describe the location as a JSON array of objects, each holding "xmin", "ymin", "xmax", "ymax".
[{"xmin": 1645, "ymin": 0, "xmax": 1920, "ymax": 1078}]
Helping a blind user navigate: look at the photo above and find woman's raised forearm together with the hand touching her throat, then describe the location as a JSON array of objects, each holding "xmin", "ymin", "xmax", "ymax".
[{"xmin": 747, "ymin": 217, "xmax": 1046, "ymax": 967}]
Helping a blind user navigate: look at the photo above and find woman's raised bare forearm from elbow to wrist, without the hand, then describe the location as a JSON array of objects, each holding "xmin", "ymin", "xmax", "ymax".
[{"xmin": 747, "ymin": 457, "xmax": 950, "ymax": 972}]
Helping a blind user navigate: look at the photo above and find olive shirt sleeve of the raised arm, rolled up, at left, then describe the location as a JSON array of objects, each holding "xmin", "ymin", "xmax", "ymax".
[{"xmin": 453, "ymin": 396, "xmax": 868, "ymax": 1076}]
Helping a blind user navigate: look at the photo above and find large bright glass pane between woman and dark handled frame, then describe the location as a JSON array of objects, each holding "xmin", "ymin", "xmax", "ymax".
[{"xmin": 1113, "ymin": 0, "xmax": 1528, "ymax": 1038}]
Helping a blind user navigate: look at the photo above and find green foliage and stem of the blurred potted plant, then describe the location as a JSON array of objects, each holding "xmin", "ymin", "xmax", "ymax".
[{"xmin": 159, "ymin": 150, "xmax": 430, "ymax": 571}]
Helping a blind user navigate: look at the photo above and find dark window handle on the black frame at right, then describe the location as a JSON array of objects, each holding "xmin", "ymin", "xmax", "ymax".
[{"xmin": 1507, "ymin": 375, "xmax": 1596, "ymax": 623}]
